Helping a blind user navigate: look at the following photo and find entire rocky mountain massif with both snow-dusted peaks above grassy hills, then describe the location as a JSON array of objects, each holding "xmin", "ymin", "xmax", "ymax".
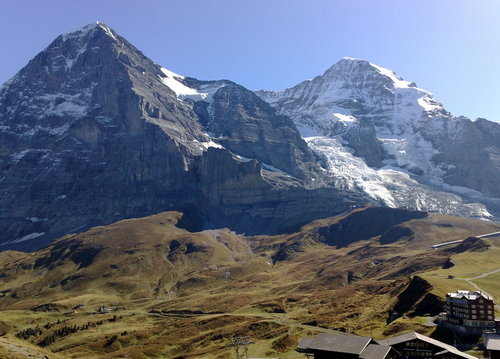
[{"xmin": 0, "ymin": 23, "xmax": 500, "ymax": 250}]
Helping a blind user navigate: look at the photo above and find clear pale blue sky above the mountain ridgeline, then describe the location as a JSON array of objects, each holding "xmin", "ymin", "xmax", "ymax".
[{"xmin": 0, "ymin": 0, "xmax": 500, "ymax": 121}]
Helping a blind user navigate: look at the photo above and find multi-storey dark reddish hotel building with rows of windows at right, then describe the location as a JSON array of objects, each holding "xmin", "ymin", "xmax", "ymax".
[{"xmin": 446, "ymin": 290, "xmax": 495, "ymax": 329}]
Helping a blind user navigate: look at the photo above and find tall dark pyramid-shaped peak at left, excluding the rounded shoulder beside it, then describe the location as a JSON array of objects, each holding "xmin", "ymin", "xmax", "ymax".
[{"xmin": 0, "ymin": 24, "xmax": 213, "ymax": 247}]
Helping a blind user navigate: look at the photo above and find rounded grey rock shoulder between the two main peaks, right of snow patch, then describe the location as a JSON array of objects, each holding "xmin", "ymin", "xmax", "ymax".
[{"xmin": 189, "ymin": 83, "xmax": 315, "ymax": 179}]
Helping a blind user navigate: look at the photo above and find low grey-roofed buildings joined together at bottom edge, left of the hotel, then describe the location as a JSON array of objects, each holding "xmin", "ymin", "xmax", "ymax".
[{"xmin": 297, "ymin": 333, "xmax": 476, "ymax": 359}]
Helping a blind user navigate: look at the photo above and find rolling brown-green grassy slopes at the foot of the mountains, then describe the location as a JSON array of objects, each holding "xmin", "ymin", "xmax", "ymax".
[{"xmin": 0, "ymin": 208, "xmax": 500, "ymax": 358}]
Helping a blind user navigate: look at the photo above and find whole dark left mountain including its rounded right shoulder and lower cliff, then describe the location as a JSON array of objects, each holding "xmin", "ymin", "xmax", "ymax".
[{"xmin": 0, "ymin": 23, "xmax": 364, "ymax": 250}]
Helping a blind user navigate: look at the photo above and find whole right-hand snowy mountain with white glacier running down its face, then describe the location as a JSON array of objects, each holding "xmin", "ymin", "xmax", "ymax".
[{"xmin": 257, "ymin": 58, "xmax": 500, "ymax": 218}]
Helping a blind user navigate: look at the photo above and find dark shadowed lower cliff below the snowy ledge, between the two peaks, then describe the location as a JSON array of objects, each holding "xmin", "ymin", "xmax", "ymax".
[{"xmin": 181, "ymin": 148, "xmax": 364, "ymax": 235}]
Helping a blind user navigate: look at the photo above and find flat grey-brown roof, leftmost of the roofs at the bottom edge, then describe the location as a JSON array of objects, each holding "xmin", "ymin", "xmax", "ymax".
[{"xmin": 297, "ymin": 333, "xmax": 372, "ymax": 359}]
